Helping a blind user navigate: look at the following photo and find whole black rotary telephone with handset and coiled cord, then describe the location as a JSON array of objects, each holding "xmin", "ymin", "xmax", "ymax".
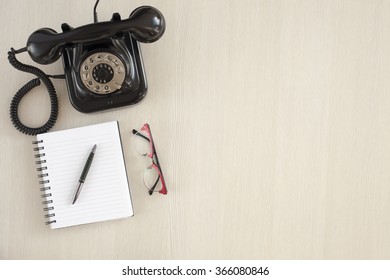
[{"xmin": 8, "ymin": 0, "xmax": 165, "ymax": 135}]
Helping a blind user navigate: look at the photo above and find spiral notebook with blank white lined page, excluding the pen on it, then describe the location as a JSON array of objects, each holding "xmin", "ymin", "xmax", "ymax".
[{"xmin": 33, "ymin": 121, "xmax": 133, "ymax": 229}]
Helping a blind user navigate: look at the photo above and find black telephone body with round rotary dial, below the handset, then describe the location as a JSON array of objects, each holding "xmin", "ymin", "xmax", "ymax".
[{"xmin": 63, "ymin": 32, "xmax": 147, "ymax": 113}]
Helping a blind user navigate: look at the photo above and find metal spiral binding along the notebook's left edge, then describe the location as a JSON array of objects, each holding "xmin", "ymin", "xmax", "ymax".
[{"xmin": 32, "ymin": 140, "xmax": 57, "ymax": 225}]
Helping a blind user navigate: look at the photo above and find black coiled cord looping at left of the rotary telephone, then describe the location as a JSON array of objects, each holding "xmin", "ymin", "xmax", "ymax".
[{"xmin": 8, "ymin": 48, "xmax": 62, "ymax": 135}]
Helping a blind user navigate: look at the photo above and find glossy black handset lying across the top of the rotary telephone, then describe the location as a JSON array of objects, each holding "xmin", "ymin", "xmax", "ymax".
[{"xmin": 27, "ymin": 6, "xmax": 165, "ymax": 64}]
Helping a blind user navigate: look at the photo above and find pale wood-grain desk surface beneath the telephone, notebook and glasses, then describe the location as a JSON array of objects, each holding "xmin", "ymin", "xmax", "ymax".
[{"xmin": 0, "ymin": 0, "xmax": 390, "ymax": 259}]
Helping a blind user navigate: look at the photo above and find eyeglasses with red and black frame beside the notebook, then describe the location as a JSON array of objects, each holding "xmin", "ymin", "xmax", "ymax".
[{"xmin": 133, "ymin": 123, "xmax": 168, "ymax": 195}]
